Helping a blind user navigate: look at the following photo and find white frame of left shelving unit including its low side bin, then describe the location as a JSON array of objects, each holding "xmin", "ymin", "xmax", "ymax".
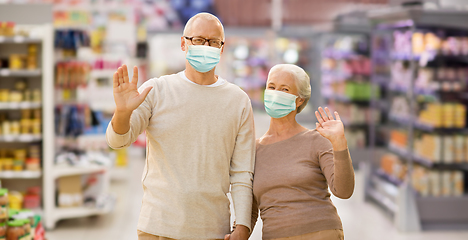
[{"xmin": 0, "ymin": 4, "xmax": 113, "ymax": 229}]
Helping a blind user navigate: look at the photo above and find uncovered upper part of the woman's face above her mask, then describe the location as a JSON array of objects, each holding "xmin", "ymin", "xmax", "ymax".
[{"xmin": 266, "ymin": 70, "xmax": 304, "ymax": 108}]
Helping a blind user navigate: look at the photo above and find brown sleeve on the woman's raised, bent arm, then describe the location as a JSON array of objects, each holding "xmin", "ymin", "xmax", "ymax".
[{"xmin": 318, "ymin": 137, "xmax": 354, "ymax": 199}]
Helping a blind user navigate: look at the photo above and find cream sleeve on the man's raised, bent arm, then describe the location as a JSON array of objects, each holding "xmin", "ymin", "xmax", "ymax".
[{"xmin": 106, "ymin": 80, "xmax": 155, "ymax": 149}]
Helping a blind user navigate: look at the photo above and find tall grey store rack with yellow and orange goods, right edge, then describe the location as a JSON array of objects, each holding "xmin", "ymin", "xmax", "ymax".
[{"xmin": 365, "ymin": 6, "xmax": 468, "ymax": 231}]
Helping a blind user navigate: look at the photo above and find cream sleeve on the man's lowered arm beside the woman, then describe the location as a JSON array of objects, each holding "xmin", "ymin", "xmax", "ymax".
[{"xmin": 229, "ymin": 101, "xmax": 255, "ymax": 231}]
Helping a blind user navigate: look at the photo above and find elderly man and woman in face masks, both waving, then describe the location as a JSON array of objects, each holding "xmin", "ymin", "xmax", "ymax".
[{"xmin": 106, "ymin": 13, "xmax": 354, "ymax": 240}]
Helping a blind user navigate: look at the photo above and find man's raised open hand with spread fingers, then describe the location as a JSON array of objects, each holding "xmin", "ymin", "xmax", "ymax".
[{"xmin": 114, "ymin": 65, "xmax": 152, "ymax": 112}]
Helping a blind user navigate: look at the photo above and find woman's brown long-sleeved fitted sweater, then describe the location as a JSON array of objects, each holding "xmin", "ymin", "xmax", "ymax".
[{"xmin": 252, "ymin": 130, "xmax": 354, "ymax": 239}]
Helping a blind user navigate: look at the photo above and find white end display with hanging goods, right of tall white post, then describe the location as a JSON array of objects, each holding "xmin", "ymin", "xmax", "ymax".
[{"xmin": 45, "ymin": 40, "xmax": 115, "ymax": 229}]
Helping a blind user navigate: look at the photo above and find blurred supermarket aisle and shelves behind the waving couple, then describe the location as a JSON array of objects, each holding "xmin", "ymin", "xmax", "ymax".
[{"xmin": 0, "ymin": 0, "xmax": 468, "ymax": 240}]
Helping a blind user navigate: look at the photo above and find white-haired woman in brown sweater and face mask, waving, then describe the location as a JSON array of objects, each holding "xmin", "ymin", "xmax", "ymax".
[{"xmin": 226, "ymin": 64, "xmax": 354, "ymax": 240}]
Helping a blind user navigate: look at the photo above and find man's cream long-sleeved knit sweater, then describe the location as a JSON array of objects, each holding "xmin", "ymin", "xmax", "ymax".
[{"xmin": 107, "ymin": 74, "xmax": 255, "ymax": 239}]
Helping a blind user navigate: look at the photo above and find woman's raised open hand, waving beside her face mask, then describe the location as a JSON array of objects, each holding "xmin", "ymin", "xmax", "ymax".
[{"xmin": 315, "ymin": 107, "xmax": 344, "ymax": 143}]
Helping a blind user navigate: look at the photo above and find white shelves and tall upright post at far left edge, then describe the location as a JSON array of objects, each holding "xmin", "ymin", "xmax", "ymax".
[{"xmin": 0, "ymin": 4, "xmax": 55, "ymax": 234}]
